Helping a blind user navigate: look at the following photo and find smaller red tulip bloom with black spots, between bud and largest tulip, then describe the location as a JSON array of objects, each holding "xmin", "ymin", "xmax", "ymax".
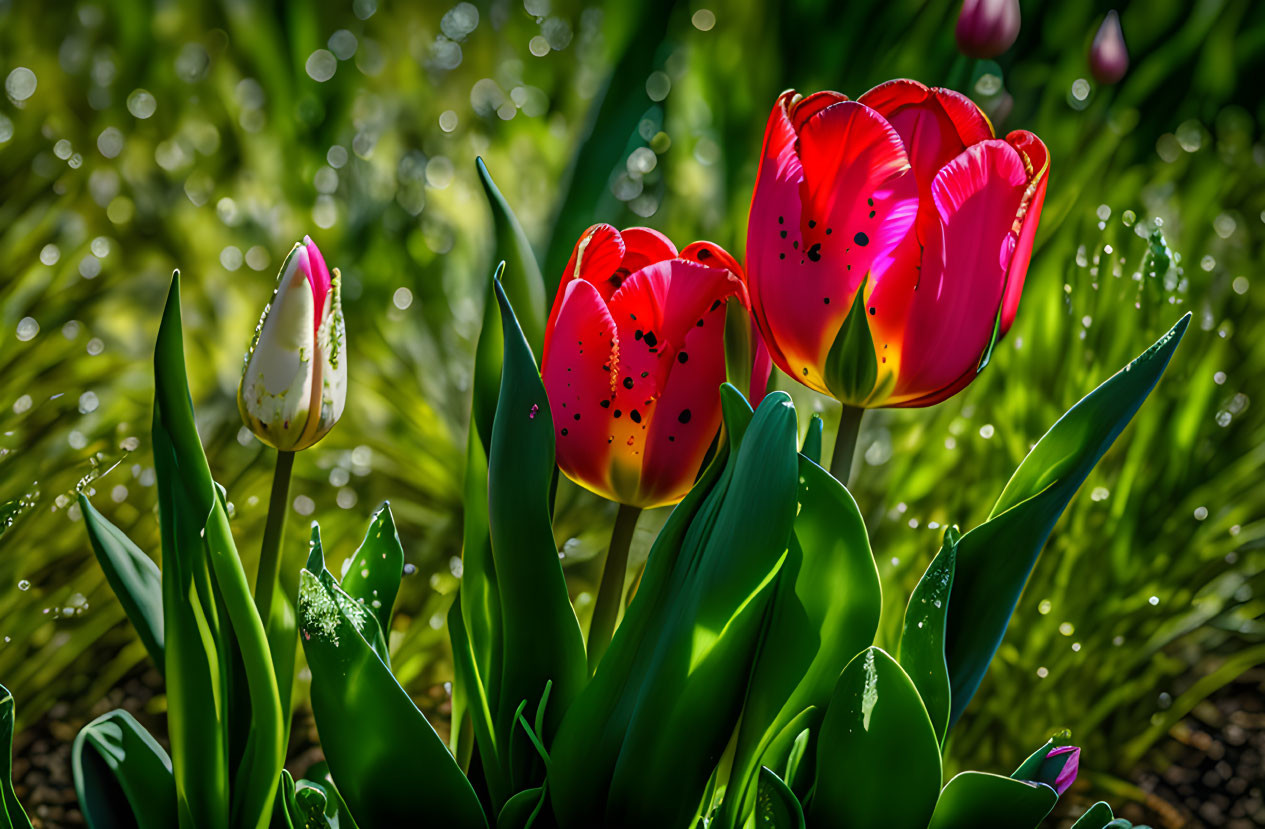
[{"xmin": 540, "ymin": 224, "xmax": 746, "ymax": 508}]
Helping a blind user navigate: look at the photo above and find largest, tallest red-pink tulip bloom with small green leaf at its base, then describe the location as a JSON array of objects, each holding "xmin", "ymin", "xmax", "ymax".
[{"xmin": 746, "ymin": 80, "xmax": 1049, "ymax": 408}]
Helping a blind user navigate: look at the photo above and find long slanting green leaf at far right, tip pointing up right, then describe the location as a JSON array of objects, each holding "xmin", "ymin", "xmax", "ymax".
[{"xmin": 945, "ymin": 314, "xmax": 1190, "ymax": 726}]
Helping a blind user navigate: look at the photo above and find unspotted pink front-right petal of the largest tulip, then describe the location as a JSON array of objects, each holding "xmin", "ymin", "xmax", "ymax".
[{"xmin": 893, "ymin": 139, "xmax": 1027, "ymax": 402}]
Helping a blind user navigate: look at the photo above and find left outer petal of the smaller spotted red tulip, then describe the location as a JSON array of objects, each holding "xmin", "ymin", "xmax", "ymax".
[{"xmin": 541, "ymin": 280, "xmax": 619, "ymax": 497}]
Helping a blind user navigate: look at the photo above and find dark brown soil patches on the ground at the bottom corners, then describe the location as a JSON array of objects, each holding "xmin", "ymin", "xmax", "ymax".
[{"xmin": 13, "ymin": 668, "xmax": 1265, "ymax": 829}]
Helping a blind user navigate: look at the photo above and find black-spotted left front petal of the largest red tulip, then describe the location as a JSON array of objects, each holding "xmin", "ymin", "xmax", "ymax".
[{"xmin": 753, "ymin": 101, "xmax": 917, "ymax": 391}]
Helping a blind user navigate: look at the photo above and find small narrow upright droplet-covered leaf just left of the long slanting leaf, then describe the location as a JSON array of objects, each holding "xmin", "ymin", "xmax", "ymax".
[{"xmin": 901, "ymin": 527, "xmax": 961, "ymax": 744}]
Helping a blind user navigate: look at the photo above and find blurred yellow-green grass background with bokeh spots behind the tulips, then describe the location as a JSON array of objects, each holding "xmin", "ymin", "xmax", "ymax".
[{"xmin": 0, "ymin": 0, "xmax": 1265, "ymax": 825}]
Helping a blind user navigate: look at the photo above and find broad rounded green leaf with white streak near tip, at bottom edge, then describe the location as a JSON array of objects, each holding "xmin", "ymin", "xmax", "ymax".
[{"xmin": 810, "ymin": 647, "xmax": 940, "ymax": 829}]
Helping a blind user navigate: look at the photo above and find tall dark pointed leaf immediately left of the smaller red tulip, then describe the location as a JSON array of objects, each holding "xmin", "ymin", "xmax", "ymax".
[{"xmin": 488, "ymin": 282, "xmax": 588, "ymax": 791}]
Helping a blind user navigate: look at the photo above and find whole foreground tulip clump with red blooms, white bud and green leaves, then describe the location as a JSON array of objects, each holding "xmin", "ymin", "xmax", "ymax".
[{"xmin": 19, "ymin": 61, "xmax": 1189, "ymax": 829}]
